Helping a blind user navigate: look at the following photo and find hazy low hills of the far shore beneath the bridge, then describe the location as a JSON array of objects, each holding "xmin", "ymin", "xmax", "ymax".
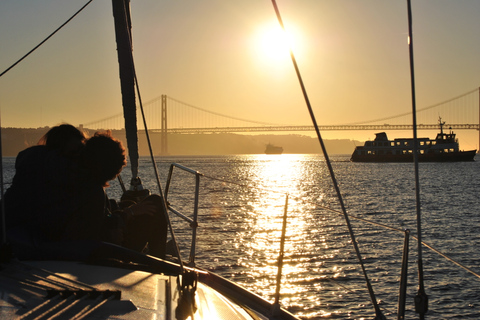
[{"xmin": 2, "ymin": 127, "xmax": 360, "ymax": 157}]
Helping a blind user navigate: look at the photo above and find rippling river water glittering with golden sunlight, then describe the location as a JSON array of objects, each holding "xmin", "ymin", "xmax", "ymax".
[{"xmin": 4, "ymin": 154, "xmax": 480, "ymax": 319}]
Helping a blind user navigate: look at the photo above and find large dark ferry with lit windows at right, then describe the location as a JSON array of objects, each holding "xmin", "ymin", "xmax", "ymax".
[{"xmin": 350, "ymin": 118, "xmax": 477, "ymax": 162}]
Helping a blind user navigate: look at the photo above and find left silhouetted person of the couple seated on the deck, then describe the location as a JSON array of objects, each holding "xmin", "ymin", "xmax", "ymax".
[{"xmin": 4, "ymin": 124, "xmax": 86, "ymax": 245}]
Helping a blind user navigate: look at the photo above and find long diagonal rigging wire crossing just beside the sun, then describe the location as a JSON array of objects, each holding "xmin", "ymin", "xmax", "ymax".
[{"xmin": 272, "ymin": 0, "xmax": 385, "ymax": 319}]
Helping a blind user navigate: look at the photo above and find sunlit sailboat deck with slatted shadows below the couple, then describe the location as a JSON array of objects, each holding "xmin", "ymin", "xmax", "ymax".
[{"xmin": 0, "ymin": 261, "xmax": 266, "ymax": 320}]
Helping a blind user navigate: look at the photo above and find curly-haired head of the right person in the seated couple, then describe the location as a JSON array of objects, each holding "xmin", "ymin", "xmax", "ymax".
[{"xmin": 83, "ymin": 131, "xmax": 127, "ymax": 186}]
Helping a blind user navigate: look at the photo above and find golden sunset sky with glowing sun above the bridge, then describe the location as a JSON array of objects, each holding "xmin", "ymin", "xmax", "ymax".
[{"xmin": 0, "ymin": 0, "xmax": 480, "ymax": 148}]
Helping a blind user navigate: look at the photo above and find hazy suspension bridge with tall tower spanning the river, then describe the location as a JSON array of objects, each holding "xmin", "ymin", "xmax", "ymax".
[{"xmin": 83, "ymin": 88, "xmax": 480, "ymax": 153}]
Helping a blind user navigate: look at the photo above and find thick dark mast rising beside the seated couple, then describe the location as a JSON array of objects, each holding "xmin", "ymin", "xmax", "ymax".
[{"xmin": 112, "ymin": 0, "xmax": 138, "ymax": 181}]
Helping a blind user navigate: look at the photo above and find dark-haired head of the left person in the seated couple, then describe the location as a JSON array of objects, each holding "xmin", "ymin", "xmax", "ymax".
[{"xmin": 38, "ymin": 124, "xmax": 87, "ymax": 157}]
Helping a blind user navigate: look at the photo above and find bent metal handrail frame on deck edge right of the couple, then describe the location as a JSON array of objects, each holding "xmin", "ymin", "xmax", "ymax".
[{"xmin": 164, "ymin": 163, "xmax": 203, "ymax": 266}]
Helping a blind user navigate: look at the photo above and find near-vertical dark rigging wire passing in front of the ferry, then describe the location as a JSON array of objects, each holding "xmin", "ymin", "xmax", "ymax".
[{"xmin": 407, "ymin": 0, "xmax": 428, "ymax": 320}]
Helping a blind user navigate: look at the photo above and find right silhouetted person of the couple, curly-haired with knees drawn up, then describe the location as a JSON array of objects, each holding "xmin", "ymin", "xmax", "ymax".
[{"xmin": 62, "ymin": 132, "xmax": 167, "ymax": 258}]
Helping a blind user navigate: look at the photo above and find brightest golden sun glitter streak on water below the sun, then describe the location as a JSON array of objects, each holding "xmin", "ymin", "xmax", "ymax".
[{"xmin": 227, "ymin": 154, "xmax": 332, "ymax": 305}]
